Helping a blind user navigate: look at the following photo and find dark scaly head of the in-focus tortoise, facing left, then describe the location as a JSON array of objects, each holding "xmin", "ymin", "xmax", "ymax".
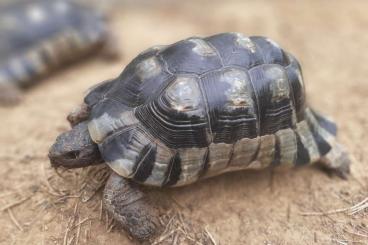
[{"xmin": 48, "ymin": 122, "xmax": 103, "ymax": 168}]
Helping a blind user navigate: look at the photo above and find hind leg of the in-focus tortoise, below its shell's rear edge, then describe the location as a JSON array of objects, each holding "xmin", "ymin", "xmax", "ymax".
[{"xmin": 319, "ymin": 142, "xmax": 351, "ymax": 179}]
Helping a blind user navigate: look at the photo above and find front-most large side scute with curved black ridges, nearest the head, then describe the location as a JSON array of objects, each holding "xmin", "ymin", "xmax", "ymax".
[{"xmin": 135, "ymin": 75, "xmax": 209, "ymax": 149}]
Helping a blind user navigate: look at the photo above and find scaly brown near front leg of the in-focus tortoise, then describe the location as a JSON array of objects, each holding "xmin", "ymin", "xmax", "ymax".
[{"xmin": 103, "ymin": 173, "xmax": 162, "ymax": 241}]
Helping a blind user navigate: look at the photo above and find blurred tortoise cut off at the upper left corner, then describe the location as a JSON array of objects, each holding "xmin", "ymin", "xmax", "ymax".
[{"xmin": 0, "ymin": 0, "xmax": 117, "ymax": 105}]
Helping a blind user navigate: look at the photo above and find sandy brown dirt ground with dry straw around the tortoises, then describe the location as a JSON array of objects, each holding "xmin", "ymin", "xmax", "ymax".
[{"xmin": 0, "ymin": 0, "xmax": 368, "ymax": 244}]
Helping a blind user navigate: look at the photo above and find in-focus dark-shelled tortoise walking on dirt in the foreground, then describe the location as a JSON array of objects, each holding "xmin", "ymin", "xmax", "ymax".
[{"xmin": 49, "ymin": 33, "xmax": 350, "ymax": 240}]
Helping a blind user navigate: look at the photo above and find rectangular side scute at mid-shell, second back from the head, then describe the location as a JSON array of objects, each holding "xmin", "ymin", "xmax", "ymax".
[{"xmin": 202, "ymin": 68, "xmax": 258, "ymax": 143}]
